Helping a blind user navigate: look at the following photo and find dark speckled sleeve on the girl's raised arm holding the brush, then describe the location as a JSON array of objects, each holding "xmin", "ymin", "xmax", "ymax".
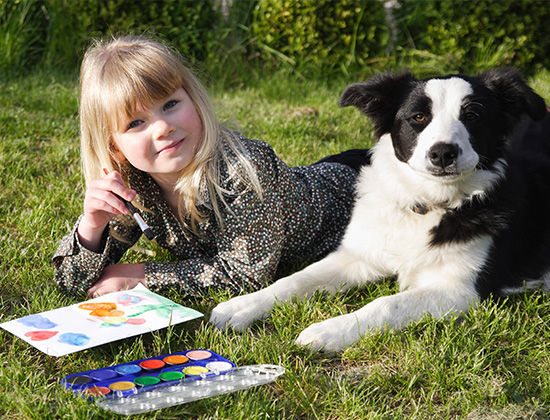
[{"xmin": 52, "ymin": 216, "xmax": 141, "ymax": 296}]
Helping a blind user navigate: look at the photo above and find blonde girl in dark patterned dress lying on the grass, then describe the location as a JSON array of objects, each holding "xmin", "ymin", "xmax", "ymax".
[{"xmin": 53, "ymin": 36, "xmax": 368, "ymax": 297}]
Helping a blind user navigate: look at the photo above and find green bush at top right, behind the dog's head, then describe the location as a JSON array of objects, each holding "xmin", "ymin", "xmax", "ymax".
[{"xmin": 394, "ymin": 0, "xmax": 550, "ymax": 72}]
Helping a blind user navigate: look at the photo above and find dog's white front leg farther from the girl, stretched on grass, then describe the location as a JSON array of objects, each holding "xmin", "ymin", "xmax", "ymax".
[{"xmin": 296, "ymin": 287, "xmax": 478, "ymax": 351}]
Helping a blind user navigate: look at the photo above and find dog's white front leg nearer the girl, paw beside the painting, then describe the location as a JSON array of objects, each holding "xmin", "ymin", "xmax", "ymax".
[{"xmin": 210, "ymin": 248, "xmax": 386, "ymax": 330}]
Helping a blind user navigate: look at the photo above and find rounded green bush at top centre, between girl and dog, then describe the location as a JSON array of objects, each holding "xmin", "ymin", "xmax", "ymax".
[{"xmin": 252, "ymin": 0, "xmax": 390, "ymax": 75}]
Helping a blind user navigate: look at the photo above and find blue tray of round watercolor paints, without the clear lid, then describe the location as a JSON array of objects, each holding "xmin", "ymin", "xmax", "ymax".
[{"xmin": 61, "ymin": 349, "xmax": 235, "ymax": 400}]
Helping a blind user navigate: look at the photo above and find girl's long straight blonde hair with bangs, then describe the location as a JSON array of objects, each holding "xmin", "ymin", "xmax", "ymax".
[{"xmin": 79, "ymin": 36, "xmax": 262, "ymax": 232}]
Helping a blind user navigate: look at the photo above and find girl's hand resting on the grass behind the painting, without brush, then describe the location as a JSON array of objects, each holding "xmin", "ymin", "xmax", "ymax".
[{"xmin": 88, "ymin": 264, "xmax": 146, "ymax": 298}]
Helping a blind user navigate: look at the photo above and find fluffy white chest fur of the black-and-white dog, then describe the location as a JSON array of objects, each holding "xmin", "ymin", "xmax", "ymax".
[{"xmin": 343, "ymin": 180, "xmax": 492, "ymax": 289}]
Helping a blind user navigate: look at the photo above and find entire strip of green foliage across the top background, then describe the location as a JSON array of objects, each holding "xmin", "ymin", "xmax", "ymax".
[{"xmin": 0, "ymin": 0, "xmax": 550, "ymax": 81}]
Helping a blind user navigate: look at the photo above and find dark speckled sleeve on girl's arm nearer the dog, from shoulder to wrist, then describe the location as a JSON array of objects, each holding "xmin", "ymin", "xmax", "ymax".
[{"xmin": 145, "ymin": 141, "xmax": 290, "ymax": 295}]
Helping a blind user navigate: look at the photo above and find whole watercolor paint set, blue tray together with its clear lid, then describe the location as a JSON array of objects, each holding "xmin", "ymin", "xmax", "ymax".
[{"xmin": 61, "ymin": 349, "xmax": 285, "ymax": 415}]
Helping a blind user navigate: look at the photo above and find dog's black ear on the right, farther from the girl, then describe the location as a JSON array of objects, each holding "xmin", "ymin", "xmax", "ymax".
[{"xmin": 479, "ymin": 68, "xmax": 548, "ymax": 122}]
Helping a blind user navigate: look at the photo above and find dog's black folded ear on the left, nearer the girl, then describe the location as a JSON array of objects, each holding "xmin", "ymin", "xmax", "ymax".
[{"xmin": 338, "ymin": 72, "xmax": 418, "ymax": 137}]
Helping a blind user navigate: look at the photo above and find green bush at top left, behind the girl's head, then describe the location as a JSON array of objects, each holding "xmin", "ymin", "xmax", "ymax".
[{"xmin": 0, "ymin": 0, "xmax": 221, "ymax": 71}]
